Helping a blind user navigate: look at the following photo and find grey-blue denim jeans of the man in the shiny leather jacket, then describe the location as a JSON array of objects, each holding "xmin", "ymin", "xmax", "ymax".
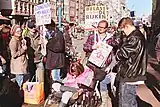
[{"xmin": 118, "ymin": 83, "xmax": 138, "ymax": 107}]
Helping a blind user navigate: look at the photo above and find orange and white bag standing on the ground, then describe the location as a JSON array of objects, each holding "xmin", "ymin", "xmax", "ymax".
[{"xmin": 23, "ymin": 75, "xmax": 45, "ymax": 104}]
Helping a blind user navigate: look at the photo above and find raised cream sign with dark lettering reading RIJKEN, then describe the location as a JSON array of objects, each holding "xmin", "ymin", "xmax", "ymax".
[{"xmin": 85, "ymin": 5, "xmax": 107, "ymax": 28}]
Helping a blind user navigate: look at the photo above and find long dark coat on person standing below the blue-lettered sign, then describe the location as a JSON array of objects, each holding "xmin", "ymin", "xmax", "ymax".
[{"xmin": 45, "ymin": 30, "xmax": 65, "ymax": 70}]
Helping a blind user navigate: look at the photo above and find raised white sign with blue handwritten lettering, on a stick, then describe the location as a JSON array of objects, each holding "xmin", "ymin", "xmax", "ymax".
[{"xmin": 34, "ymin": 2, "xmax": 51, "ymax": 25}]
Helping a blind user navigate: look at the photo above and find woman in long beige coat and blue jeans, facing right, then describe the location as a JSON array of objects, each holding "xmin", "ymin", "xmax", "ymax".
[{"xmin": 9, "ymin": 25, "xmax": 28, "ymax": 88}]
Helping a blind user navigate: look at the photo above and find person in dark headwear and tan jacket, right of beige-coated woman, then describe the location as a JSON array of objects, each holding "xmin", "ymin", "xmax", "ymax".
[{"xmin": 23, "ymin": 21, "xmax": 44, "ymax": 82}]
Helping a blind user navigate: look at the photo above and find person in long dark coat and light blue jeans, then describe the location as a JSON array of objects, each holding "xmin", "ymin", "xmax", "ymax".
[{"xmin": 45, "ymin": 20, "xmax": 65, "ymax": 80}]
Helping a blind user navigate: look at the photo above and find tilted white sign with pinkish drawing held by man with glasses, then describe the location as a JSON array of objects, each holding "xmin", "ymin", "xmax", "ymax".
[{"xmin": 88, "ymin": 41, "xmax": 113, "ymax": 67}]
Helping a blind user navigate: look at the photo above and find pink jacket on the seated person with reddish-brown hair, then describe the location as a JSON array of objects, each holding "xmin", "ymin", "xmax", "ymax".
[{"xmin": 63, "ymin": 66, "xmax": 94, "ymax": 88}]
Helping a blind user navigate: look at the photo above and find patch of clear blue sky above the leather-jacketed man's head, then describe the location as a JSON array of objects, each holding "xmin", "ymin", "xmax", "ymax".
[{"xmin": 126, "ymin": 0, "xmax": 152, "ymax": 17}]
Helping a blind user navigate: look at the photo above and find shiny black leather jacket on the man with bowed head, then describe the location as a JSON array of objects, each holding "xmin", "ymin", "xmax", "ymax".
[{"xmin": 116, "ymin": 30, "xmax": 147, "ymax": 82}]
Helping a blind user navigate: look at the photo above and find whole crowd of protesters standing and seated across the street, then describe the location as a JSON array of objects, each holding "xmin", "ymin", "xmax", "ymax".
[{"xmin": 0, "ymin": 17, "xmax": 156, "ymax": 107}]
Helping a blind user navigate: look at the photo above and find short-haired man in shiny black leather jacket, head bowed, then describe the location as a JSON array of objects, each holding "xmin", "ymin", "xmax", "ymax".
[{"xmin": 116, "ymin": 17, "xmax": 147, "ymax": 107}]
